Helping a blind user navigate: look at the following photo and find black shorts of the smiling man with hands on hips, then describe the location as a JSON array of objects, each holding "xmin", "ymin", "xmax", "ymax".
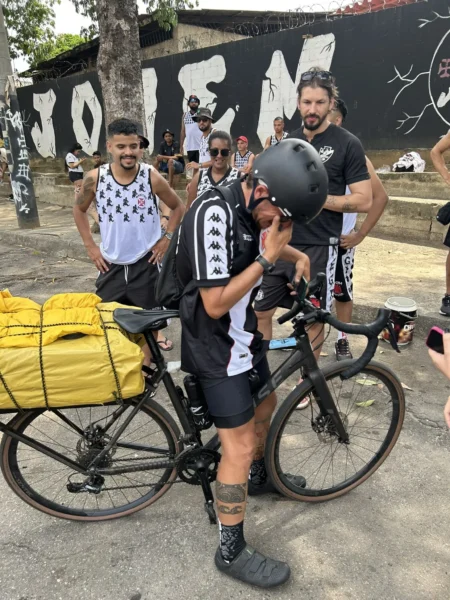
[{"xmin": 95, "ymin": 252, "xmax": 160, "ymax": 310}]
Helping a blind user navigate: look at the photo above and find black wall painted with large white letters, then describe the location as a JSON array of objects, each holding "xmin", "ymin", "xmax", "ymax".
[{"xmin": 18, "ymin": 0, "xmax": 450, "ymax": 157}]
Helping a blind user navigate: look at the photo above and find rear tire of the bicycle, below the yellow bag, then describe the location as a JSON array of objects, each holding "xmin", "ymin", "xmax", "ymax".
[{"xmin": 0, "ymin": 399, "xmax": 182, "ymax": 522}]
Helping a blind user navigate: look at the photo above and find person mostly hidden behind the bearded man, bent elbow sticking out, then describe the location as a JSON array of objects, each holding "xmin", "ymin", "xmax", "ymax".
[{"xmin": 328, "ymin": 98, "xmax": 389, "ymax": 360}]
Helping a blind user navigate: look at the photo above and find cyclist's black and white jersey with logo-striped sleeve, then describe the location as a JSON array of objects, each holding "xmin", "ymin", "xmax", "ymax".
[{"xmin": 177, "ymin": 181, "xmax": 265, "ymax": 378}]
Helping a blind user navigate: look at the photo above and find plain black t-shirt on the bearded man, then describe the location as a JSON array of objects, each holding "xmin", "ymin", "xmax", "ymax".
[{"xmin": 289, "ymin": 123, "xmax": 370, "ymax": 247}]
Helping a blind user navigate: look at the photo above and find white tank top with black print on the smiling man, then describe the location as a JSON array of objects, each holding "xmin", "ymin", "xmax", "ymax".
[{"xmin": 95, "ymin": 163, "xmax": 161, "ymax": 265}]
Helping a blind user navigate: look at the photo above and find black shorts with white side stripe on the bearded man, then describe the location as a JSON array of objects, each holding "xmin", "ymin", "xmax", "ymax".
[{"xmin": 255, "ymin": 246, "xmax": 338, "ymax": 312}]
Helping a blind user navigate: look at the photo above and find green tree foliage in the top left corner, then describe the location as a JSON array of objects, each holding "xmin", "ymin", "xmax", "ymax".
[{"xmin": 3, "ymin": 0, "xmax": 60, "ymax": 58}]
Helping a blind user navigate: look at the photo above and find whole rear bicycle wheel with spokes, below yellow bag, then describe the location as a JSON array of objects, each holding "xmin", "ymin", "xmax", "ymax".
[{"xmin": 0, "ymin": 400, "xmax": 181, "ymax": 521}]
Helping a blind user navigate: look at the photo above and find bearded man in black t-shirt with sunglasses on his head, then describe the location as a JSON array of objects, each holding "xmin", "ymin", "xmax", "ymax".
[{"xmin": 255, "ymin": 68, "xmax": 372, "ymax": 368}]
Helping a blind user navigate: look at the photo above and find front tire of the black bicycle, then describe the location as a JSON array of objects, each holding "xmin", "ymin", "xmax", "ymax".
[{"xmin": 265, "ymin": 360, "xmax": 405, "ymax": 502}]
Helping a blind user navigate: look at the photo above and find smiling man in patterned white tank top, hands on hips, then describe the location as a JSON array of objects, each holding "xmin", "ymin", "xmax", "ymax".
[{"xmin": 73, "ymin": 119, "xmax": 184, "ymax": 362}]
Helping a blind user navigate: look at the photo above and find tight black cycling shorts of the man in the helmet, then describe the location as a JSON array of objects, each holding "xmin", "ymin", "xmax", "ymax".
[{"xmin": 200, "ymin": 356, "xmax": 270, "ymax": 429}]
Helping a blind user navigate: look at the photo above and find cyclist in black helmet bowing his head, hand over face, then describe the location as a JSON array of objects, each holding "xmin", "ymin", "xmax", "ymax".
[{"xmin": 177, "ymin": 139, "xmax": 328, "ymax": 588}]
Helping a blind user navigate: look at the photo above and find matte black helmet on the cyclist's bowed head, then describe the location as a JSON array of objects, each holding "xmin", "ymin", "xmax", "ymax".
[{"xmin": 253, "ymin": 138, "xmax": 328, "ymax": 223}]
